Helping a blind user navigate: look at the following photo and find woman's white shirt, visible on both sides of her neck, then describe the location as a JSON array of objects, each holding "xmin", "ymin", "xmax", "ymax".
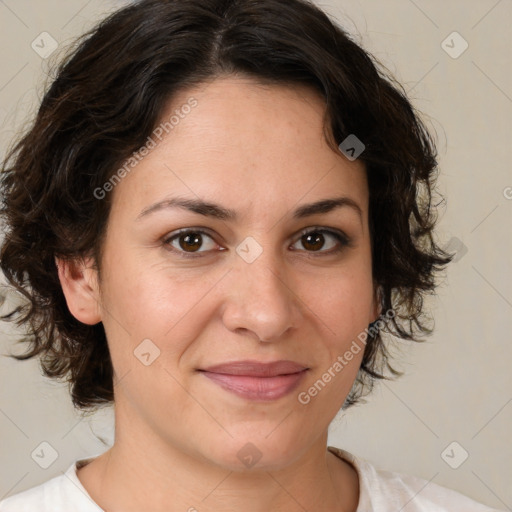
[{"xmin": 0, "ymin": 446, "xmax": 499, "ymax": 512}]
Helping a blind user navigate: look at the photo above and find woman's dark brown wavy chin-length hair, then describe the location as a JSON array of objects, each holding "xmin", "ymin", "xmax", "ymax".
[{"xmin": 0, "ymin": 0, "xmax": 453, "ymax": 410}]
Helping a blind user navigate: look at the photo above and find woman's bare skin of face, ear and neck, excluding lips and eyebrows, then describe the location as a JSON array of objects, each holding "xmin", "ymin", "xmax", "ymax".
[{"xmin": 58, "ymin": 77, "xmax": 379, "ymax": 512}]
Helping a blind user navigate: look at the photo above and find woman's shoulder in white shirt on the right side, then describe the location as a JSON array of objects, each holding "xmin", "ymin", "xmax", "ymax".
[{"xmin": 329, "ymin": 446, "xmax": 498, "ymax": 512}]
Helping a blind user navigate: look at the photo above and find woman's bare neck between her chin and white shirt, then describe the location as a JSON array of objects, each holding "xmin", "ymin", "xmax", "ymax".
[{"xmin": 77, "ymin": 406, "xmax": 359, "ymax": 512}]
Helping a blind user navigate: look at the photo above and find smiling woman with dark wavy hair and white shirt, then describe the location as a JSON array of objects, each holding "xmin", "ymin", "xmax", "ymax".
[{"xmin": 0, "ymin": 0, "xmax": 502, "ymax": 512}]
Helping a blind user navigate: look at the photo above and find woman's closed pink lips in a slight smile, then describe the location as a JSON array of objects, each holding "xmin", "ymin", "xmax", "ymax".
[{"xmin": 200, "ymin": 361, "xmax": 309, "ymax": 401}]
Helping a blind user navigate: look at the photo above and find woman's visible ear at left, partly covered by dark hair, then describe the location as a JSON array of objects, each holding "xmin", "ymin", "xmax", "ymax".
[{"xmin": 55, "ymin": 258, "xmax": 101, "ymax": 325}]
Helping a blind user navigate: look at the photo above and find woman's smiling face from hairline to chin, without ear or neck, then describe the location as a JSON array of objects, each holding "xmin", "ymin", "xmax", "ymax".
[{"xmin": 84, "ymin": 78, "xmax": 378, "ymax": 469}]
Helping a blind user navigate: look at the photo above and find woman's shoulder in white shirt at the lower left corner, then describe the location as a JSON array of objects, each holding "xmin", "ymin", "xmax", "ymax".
[{"xmin": 0, "ymin": 461, "xmax": 101, "ymax": 512}]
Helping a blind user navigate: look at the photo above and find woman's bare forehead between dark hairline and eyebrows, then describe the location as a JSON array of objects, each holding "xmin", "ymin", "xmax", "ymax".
[{"xmin": 109, "ymin": 77, "xmax": 367, "ymax": 220}]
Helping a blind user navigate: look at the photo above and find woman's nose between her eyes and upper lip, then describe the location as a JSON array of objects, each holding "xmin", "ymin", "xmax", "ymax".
[{"xmin": 222, "ymin": 244, "xmax": 301, "ymax": 342}]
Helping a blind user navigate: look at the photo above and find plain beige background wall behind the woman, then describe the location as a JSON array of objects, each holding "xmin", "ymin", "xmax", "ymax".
[{"xmin": 0, "ymin": 0, "xmax": 512, "ymax": 510}]
